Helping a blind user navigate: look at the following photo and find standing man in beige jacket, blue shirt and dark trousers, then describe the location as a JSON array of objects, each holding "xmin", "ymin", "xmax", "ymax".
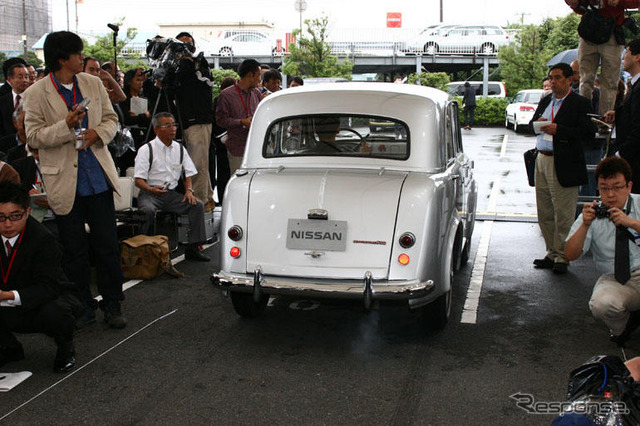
[{"xmin": 24, "ymin": 31, "xmax": 126, "ymax": 328}]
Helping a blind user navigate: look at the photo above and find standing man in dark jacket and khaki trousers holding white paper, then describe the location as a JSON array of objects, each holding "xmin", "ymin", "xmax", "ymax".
[{"xmin": 531, "ymin": 63, "xmax": 596, "ymax": 274}]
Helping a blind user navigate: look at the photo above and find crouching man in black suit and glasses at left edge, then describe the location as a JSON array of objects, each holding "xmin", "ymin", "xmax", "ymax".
[{"xmin": 0, "ymin": 182, "xmax": 80, "ymax": 373}]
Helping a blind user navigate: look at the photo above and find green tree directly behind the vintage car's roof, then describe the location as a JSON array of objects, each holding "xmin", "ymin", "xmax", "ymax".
[{"xmin": 282, "ymin": 16, "xmax": 353, "ymax": 79}]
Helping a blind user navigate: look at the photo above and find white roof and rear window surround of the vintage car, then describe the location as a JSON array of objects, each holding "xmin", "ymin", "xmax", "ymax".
[{"xmin": 243, "ymin": 83, "xmax": 453, "ymax": 171}]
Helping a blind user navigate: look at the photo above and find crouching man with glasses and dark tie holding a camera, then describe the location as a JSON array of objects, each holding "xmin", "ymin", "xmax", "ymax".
[{"xmin": 565, "ymin": 157, "xmax": 640, "ymax": 347}]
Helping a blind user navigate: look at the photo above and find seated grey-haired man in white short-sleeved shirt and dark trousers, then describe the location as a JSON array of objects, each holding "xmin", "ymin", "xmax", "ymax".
[{"xmin": 135, "ymin": 112, "xmax": 210, "ymax": 262}]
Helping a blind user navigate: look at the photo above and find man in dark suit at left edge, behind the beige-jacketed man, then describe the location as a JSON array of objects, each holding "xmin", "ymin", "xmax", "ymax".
[{"xmin": 0, "ymin": 64, "xmax": 29, "ymax": 154}]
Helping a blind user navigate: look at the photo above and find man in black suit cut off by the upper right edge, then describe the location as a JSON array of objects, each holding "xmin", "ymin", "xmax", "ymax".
[{"xmin": 605, "ymin": 39, "xmax": 640, "ymax": 194}]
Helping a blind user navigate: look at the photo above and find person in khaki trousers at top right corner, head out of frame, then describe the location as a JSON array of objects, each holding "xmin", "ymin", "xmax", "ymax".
[{"xmin": 565, "ymin": 0, "xmax": 640, "ymax": 115}]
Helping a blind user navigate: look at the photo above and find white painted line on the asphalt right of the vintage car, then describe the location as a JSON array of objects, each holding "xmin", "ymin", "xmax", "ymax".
[{"xmin": 460, "ymin": 175, "xmax": 506, "ymax": 324}]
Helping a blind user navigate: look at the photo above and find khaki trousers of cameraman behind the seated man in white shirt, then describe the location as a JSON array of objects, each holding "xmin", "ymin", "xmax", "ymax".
[{"xmin": 182, "ymin": 124, "xmax": 213, "ymax": 204}]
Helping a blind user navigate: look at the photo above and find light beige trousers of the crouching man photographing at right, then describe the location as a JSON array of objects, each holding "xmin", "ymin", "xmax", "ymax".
[{"xmin": 589, "ymin": 270, "xmax": 640, "ymax": 336}]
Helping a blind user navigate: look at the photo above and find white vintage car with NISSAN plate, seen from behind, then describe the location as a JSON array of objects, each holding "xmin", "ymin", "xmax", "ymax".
[{"xmin": 212, "ymin": 83, "xmax": 477, "ymax": 326}]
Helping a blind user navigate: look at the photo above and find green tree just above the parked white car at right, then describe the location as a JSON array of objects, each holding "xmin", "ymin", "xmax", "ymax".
[{"xmin": 498, "ymin": 25, "xmax": 553, "ymax": 93}]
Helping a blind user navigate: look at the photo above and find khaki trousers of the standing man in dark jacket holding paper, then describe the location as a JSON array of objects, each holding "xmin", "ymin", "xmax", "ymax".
[{"xmin": 535, "ymin": 153, "xmax": 578, "ymax": 263}]
